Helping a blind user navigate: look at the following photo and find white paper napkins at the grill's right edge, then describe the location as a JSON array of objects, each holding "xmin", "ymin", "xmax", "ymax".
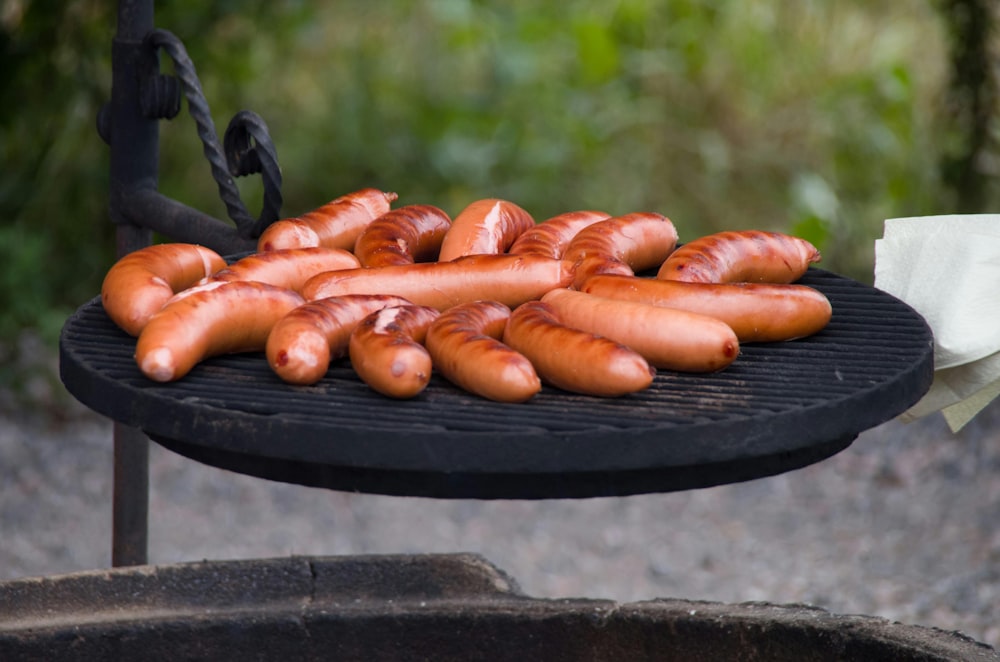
[{"xmin": 875, "ymin": 214, "xmax": 1000, "ymax": 432}]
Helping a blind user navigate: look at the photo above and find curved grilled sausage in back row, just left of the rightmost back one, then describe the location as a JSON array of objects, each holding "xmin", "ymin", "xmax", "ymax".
[{"xmin": 563, "ymin": 212, "xmax": 677, "ymax": 287}]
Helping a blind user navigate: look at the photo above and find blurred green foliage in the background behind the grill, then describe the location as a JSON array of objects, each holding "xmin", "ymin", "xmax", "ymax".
[{"xmin": 0, "ymin": 0, "xmax": 995, "ymax": 408}]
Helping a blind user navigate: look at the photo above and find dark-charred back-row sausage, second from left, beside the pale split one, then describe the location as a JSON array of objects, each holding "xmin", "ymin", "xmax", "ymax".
[{"xmin": 354, "ymin": 205, "xmax": 451, "ymax": 267}]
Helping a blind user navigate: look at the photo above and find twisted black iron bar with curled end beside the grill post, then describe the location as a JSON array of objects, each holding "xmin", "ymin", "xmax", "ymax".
[{"xmin": 146, "ymin": 29, "xmax": 282, "ymax": 238}]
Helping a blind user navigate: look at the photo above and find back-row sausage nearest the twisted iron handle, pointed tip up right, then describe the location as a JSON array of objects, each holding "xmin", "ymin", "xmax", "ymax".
[{"xmin": 257, "ymin": 188, "xmax": 399, "ymax": 251}]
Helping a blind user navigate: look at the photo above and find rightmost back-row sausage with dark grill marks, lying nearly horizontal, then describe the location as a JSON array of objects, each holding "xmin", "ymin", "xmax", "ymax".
[{"xmin": 656, "ymin": 230, "xmax": 821, "ymax": 283}]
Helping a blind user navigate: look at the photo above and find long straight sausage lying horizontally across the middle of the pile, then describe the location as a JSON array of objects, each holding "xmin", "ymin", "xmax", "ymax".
[{"xmin": 302, "ymin": 255, "xmax": 573, "ymax": 310}]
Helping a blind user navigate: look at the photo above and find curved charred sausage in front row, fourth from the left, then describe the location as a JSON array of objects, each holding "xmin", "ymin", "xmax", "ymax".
[{"xmin": 425, "ymin": 301, "xmax": 542, "ymax": 402}]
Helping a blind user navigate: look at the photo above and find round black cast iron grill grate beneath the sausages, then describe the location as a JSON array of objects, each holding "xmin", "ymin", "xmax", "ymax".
[{"xmin": 60, "ymin": 269, "xmax": 933, "ymax": 499}]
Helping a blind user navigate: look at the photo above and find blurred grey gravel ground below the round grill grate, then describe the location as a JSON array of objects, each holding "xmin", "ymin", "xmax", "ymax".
[{"xmin": 0, "ymin": 384, "xmax": 1000, "ymax": 648}]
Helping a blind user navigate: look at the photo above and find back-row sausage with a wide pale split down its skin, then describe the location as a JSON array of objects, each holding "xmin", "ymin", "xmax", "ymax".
[{"xmin": 438, "ymin": 198, "xmax": 535, "ymax": 262}]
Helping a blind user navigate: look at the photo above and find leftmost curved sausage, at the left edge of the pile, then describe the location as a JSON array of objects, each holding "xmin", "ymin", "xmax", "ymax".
[{"xmin": 101, "ymin": 243, "xmax": 226, "ymax": 336}]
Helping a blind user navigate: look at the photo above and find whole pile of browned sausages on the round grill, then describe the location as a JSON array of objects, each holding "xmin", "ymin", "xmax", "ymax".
[{"xmin": 101, "ymin": 189, "xmax": 832, "ymax": 402}]
